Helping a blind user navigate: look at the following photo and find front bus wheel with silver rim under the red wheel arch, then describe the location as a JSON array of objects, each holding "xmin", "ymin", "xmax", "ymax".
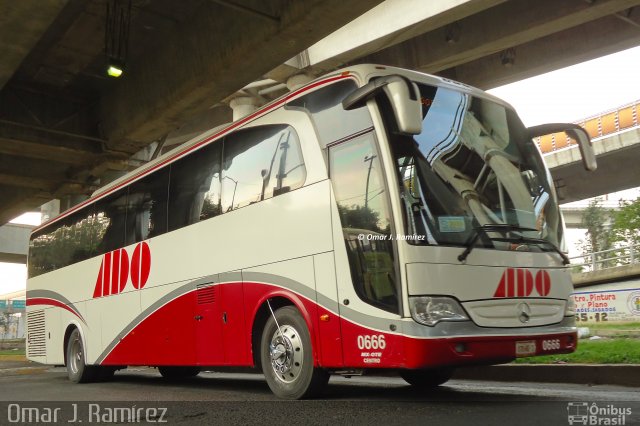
[{"xmin": 260, "ymin": 306, "xmax": 329, "ymax": 399}]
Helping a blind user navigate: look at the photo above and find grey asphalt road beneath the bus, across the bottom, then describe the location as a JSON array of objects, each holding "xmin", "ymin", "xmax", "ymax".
[{"xmin": 0, "ymin": 364, "xmax": 640, "ymax": 426}]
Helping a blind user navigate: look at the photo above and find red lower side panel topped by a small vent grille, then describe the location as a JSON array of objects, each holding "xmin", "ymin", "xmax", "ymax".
[{"xmin": 193, "ymin": 275, "xmax": 224, "ymax": 365}]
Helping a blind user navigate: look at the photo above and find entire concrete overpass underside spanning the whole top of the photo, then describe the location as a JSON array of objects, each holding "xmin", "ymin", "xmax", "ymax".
[{"xmin": 0, "ymin": 0, "xmax": 640, "ymax": 224}]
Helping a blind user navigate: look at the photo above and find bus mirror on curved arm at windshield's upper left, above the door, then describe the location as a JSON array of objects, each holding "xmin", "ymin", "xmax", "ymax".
[{"xmin": 342, "ymin": 75, "xmax": 422, "ymax": 135}]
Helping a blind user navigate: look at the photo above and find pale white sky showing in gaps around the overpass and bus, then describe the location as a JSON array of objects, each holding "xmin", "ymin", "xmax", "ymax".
[{"xmin": 0, "ymin": 47, "xmax": 640, "ymax": 295}]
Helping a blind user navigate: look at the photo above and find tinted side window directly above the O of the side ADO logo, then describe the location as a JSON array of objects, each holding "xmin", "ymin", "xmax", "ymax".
[{"xmin": 126, "ymin": 167, "xmax": 169, "ymax": 245}]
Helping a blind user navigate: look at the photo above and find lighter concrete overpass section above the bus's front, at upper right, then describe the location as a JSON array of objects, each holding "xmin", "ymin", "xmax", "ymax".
[{"xmin": 285, "ymin": 0, "xmax": 640, "ymax": 89}]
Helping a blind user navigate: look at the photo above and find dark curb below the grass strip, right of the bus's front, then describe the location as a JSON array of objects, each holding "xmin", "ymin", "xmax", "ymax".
[{"xmin": 452, "ymin": 364, "xmax": 640, "ymax": 387}]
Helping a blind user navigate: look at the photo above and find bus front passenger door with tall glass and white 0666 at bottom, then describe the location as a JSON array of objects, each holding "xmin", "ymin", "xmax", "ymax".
[{"xmin": 329, "ymin": 131, "xmax": 401, "ymax": 367}]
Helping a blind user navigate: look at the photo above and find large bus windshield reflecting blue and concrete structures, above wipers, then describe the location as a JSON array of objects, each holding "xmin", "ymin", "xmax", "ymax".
[{"xmin": 392, "ymin": 84, "xmax": 563, "ymax": 251}]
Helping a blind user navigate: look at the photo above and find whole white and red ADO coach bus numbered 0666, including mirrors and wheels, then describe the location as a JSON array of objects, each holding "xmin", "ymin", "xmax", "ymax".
[{"xmin": 27, "ymin": 65, "xmax": 595, "ymax": 398}]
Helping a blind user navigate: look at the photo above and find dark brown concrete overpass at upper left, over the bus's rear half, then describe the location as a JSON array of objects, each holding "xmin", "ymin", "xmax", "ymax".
[{"xmin": 0, "ymin": 0, "xmax": 381, "ymax": 224}]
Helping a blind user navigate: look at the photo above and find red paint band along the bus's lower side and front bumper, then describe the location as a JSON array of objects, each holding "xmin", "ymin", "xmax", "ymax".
[{"xmin": 97, "ymin": 282, "xmax": 577, "ymax": 369}]
